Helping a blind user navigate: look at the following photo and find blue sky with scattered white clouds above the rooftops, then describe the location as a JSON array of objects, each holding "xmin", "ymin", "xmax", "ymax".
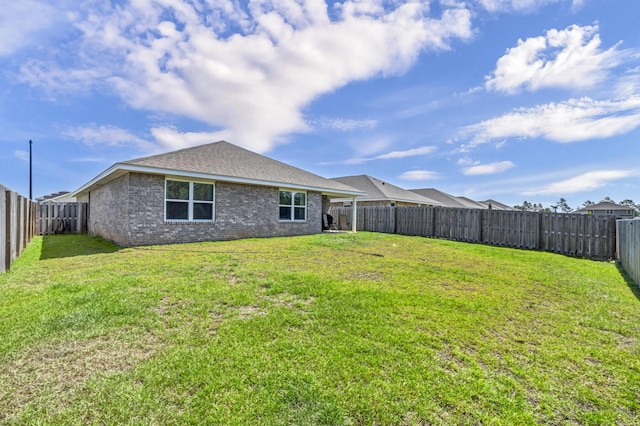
[{"xmin": 0, "ymin": 0, "xmax": 640, "ymax": 208}]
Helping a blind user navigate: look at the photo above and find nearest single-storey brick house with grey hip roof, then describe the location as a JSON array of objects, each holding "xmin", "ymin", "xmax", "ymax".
[{"xmin": 72, "ymin": 141, "xmax": 365, "ymax": 246}]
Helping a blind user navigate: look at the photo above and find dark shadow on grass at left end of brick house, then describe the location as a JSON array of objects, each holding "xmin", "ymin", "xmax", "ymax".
[{"xmin": 40, "ymin": 234, "xmax": 121, "ymax": 260}]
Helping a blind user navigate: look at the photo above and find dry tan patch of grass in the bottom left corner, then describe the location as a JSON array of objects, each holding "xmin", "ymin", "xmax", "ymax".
[{"xmin": 0, "ymin": 335, "xmax": 158, "ymax": 423}]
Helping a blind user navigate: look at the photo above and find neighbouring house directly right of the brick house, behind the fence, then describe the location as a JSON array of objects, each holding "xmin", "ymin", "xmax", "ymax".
[{"xmin": 331, "ymin": 175, "xmax": 441, "ymax": 207}]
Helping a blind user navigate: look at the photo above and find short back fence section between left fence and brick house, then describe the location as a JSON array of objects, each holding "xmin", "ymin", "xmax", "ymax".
[{"xmin": 37, "ymin": 202, "xmax": 87, "ymax": 235}]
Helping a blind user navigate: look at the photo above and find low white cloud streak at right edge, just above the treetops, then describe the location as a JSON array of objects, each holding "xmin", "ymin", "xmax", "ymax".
[{"xmin": 522, "ymin": 170, "xmax": 639, "ymax": 196}]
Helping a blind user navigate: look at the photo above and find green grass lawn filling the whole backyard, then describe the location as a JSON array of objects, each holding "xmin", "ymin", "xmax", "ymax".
[{"xmin": 0, "ymin": 232, "xmax": 640, "ymax": 425}]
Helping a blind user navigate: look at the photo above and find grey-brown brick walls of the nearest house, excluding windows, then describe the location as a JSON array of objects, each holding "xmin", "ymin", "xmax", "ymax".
[{"xmin": 91, "ymin": 173, "xmax": 323, "ymax": 246}]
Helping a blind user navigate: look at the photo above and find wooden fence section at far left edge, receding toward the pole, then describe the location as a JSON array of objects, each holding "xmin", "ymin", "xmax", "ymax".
[{"xmin": 0, "ymin": 185, "xmax": 36, "ymax": 272}]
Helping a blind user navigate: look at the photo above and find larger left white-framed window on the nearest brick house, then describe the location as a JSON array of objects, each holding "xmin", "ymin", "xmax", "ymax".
[{"xmin": 164, "ymin": 179, "xmax": 214, "ymax": 222}]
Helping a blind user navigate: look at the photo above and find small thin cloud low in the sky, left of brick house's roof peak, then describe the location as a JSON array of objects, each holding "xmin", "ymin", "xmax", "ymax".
[{"xmin": 62, "ymin": 124, "xmax": 154, "ymax": 149}]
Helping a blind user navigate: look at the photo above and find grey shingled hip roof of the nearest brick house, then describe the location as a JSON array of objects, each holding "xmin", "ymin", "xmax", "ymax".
[{"xmin": 72, "ymin": 141, "xmax": 365, "ymax": 196}]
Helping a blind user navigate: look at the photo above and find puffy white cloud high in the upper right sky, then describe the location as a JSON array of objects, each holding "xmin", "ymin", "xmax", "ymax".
[{"xmin": 485, "ymin": 25, "xmax": 625, "ymax": 93}]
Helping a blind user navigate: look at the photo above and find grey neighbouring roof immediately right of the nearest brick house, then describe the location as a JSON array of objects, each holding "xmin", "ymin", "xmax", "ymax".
[{"xmin": 331, "ymin": 175, "xmax": 441, "ymax": 206}]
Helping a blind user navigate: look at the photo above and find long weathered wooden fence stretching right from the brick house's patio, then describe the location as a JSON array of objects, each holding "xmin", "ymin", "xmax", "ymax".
[{"xmin": 329, "ymin": 207, "xmax": 616, "ymax": 260}]
